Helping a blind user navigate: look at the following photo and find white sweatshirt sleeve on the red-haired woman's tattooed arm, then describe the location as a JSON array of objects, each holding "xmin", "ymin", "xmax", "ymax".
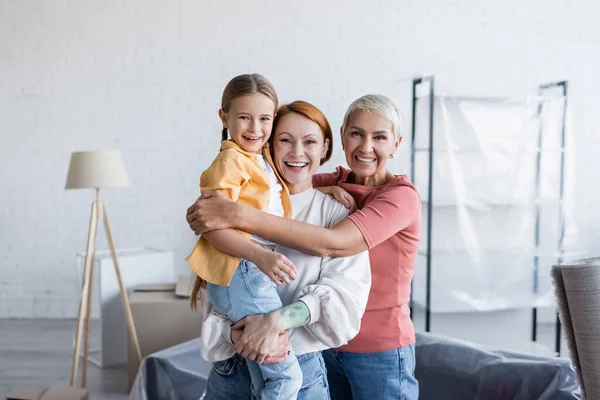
[{"xmin": 298, "ymin": 201, "xmax": 371, "ymax": 348}]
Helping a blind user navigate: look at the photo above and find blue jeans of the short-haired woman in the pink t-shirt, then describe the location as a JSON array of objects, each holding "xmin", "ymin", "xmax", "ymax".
[{"xmin": 323, "ymin": 345, "xmax": 419, "ymax": 400}]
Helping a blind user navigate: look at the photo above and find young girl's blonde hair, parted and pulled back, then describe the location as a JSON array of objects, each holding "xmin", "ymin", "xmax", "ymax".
[{"xmin": 221, "ymin": 74, "xmax": 278, "ymax": 140}]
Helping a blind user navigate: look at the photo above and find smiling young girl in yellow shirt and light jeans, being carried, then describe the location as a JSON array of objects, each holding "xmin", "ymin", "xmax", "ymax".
[{"xmin": 186, "ymin": 74, "xmax": 302, "ymax": 399}]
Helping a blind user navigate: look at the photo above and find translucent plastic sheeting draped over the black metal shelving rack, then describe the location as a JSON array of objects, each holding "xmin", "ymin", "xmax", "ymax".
[{"xmin": 413, "ymin": 96, "xmax": 574, "ymax": 313}]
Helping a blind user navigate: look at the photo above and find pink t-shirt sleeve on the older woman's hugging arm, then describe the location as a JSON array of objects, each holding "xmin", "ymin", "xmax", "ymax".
[{"xmin": 348, "ymin": 186, "xmax": 421, "ymax": 249}]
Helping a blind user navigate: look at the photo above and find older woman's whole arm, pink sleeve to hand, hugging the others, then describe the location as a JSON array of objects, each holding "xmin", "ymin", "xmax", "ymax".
[{"xmin": 187, "ymin": 186, "xmax": 421, "ymax": 257}]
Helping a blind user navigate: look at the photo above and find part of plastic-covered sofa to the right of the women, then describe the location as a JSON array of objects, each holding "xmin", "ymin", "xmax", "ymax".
[{"xmin": 415, "ymin": 333, "xmax": 582, "ymax": 400}]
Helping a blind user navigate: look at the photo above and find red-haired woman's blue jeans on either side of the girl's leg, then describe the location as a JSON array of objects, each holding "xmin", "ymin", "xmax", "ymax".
[{"xmin": 204, "ymin": 352, "xmax": 330, "ymax": 400}]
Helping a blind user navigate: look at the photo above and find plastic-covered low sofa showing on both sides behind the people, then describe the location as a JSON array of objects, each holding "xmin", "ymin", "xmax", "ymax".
[{"xmin": 130, "ymin": 333, "xmax": 581, "ymax": 400}]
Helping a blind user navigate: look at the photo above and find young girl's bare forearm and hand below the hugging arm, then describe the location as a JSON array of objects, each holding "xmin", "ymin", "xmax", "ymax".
[{"xmin": 204, "ymin": 229, "xmax": 297, "ymax": 285}]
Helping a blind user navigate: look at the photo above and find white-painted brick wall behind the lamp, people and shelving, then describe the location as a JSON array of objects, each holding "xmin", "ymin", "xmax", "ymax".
[{"xmin": 0, "ymin": 0, "xmax": 600, "ymax": 318}]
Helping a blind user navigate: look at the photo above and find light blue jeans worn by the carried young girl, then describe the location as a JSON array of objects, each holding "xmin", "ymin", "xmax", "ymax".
[{"xmin": 206, "ymin": 259, "xmax": 302, "ymax": 400}]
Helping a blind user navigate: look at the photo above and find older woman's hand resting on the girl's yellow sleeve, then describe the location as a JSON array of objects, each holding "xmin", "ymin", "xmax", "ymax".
[{"xmin": 186, "ymin": 191, "xmax": 238, "ymax": 235}]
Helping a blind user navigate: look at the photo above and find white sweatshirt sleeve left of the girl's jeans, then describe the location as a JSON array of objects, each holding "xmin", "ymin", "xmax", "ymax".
[{"xmin": 199, "ymin": 288, "xmax": 235, "ymax": 362}]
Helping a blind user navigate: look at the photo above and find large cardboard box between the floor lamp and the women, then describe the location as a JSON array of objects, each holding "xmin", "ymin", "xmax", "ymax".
[{"xmin": 129, "ymin": 278, "xmax": 202, "ymax": 390}]
